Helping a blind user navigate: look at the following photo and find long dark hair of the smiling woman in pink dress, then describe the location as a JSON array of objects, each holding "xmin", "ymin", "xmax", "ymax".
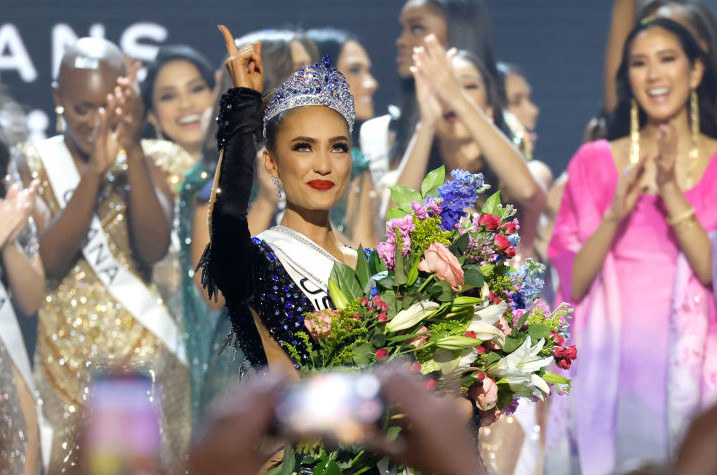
[{"xmin": 607, "ymin": 18, "xmax": 717, "ymax": 140}]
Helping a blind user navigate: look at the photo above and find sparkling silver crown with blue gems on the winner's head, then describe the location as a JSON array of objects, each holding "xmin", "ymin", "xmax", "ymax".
[{"xmin": 264, "ymin": 55, "xmax": 356, "ymax": 132}]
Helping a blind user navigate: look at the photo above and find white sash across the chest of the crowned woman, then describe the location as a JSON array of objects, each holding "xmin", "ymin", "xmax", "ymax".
[{"xmin": 258, "ymin": 226, "xmax": 336, "ymax": 310}]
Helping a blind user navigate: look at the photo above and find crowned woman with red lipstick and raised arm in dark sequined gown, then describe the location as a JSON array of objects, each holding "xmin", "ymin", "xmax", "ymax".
[{"xmin": 200, "ymin": 27, "xmax": 356, "ymax": 369}]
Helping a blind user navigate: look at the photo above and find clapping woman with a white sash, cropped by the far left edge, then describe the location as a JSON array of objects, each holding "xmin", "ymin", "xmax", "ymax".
[{"xmin": 0, "ymin": 139, "xmax": 45, "ymax": 475}]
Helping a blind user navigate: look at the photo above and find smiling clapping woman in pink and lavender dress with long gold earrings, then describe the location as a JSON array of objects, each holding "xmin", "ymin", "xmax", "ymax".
[{"xmin": 548, "ymin": 19, "xmax": 717, "ymax": 474}]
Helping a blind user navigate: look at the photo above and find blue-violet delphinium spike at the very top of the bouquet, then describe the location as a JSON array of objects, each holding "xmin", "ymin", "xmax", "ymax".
[{"xmin": 438, "ymin": 170, "xmax": 483, "ymax": 231}]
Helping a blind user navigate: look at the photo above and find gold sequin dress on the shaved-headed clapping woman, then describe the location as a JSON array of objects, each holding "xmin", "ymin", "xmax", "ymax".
[{"xmin": 18, "ymin": 141, "xmax": 190, "ymax": 474}]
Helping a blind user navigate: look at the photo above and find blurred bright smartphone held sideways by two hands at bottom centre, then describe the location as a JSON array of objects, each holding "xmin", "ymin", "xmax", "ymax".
[{"xmin": 276, "ymin": 372, "xmax": 385, "ymax": 444}]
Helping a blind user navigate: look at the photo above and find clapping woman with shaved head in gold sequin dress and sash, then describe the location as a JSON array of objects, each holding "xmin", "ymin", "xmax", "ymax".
[{"xmin": 18, "ymin": 38, "xmax": 189, "ymax": 473}]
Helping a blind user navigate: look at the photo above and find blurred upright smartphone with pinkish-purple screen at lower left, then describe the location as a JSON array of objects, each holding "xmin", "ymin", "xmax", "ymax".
[{"xmin": 83, "ymin": 372, "xmax": 161, "ymax": 475}]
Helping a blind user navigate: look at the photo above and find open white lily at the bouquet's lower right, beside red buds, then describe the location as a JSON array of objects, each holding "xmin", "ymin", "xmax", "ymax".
[{"xmin": 488, "ymin": 336, "xmax": 553, "ymax": 398}]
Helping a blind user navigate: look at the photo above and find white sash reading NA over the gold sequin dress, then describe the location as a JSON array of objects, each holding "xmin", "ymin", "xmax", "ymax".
[{"xmin": 36, "ymin": 135, "xmax": 187, "ymax": 365}]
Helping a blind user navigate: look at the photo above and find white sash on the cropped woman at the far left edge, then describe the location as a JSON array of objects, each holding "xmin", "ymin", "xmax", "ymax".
[{"xmin": 0, "ymin": 282, "xmax": 52, "ymax": 470}]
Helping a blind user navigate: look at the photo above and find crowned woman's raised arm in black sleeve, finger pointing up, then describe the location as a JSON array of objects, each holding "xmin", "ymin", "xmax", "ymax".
[{"xmin": 200, "ymin": 26, "xmax": 263, "ymax": 300}]
